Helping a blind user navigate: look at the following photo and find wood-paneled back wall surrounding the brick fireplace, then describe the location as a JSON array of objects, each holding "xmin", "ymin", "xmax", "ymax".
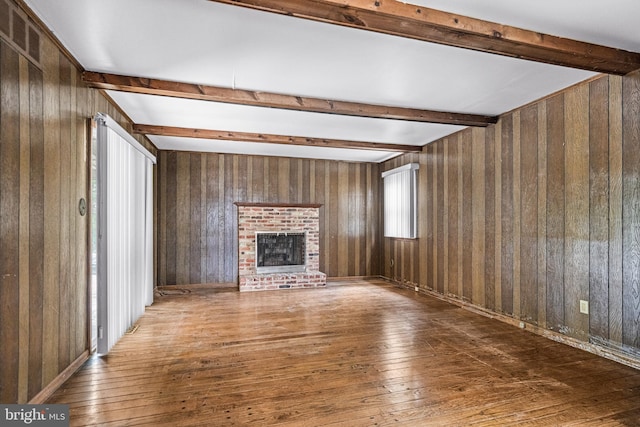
[{"xmin": 157, "ymin": 151, "xmax": 381, "ymax": 285}]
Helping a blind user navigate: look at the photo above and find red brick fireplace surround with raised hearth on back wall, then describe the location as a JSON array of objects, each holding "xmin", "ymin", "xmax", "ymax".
[{"xmin": 235, "ymin": 202, "xmax": 327, "ymax": 292}]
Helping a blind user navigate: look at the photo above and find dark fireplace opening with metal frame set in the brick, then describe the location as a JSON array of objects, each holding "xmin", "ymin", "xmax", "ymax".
[{"xmin": 256, "ymin": 232, "xmax": 307, "ymax": 274}]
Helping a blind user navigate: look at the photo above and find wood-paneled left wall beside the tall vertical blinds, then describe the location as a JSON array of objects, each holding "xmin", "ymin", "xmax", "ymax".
[{"xmin": 0, "ymin": 0, "xmax": 155, "ymax": 403}]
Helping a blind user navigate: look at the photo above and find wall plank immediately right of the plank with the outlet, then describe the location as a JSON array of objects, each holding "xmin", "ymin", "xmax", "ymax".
[{"xmin": 589, "ymin": 79, "xmax": 609, "ymax": 338}]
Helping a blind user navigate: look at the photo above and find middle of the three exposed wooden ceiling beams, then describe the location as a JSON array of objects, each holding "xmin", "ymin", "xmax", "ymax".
[{"xmin": 82, "ymin": 71, "xmax": 498, "ymax": 127}]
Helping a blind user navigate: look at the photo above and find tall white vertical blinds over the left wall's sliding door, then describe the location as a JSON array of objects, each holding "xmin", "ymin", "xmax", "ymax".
[{"xmin": 96, "ymin": 114, "xmax": 155, "ymax": 354}]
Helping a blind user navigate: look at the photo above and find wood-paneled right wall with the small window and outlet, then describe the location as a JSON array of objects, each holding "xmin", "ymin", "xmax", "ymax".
[{"xmin": 383, "ymin": 73, "xmax": 640, "ymax": 354}]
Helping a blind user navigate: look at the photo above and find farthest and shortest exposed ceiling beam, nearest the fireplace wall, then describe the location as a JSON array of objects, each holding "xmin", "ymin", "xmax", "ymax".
[{"xmin": 133, "ymin": 124, "xmax": 422, "ymax": 153}]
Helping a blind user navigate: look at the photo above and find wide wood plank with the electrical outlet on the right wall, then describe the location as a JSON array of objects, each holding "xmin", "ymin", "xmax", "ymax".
[{"xmin": 564, "ymin": 85, "xmax": 589, "ymax": 338}]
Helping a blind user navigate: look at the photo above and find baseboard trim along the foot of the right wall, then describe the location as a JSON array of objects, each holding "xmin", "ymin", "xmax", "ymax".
[{"xmin": 380, "ymin": 276, "xmax": 640, "ymax": 370}]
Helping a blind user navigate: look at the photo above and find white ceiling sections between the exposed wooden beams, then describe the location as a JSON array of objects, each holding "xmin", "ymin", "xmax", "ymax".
[{"xmin": 25, "ymin": 0, "xmax": 640, "ymax": 162}]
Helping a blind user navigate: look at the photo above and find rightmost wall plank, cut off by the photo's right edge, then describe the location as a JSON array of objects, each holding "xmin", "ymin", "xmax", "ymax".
[{"xmin": 622, "ymin": 73, "xmax": 640, "ymax": 348}]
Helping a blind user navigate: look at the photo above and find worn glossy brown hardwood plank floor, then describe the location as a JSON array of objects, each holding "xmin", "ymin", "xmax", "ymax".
[{"xmin": 49, "ymin": 281, "xmax": 640, "ymax": 426}]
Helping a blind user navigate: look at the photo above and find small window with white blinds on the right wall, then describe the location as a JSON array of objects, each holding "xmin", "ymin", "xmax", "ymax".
[{"xmin": 382, "ymin": 163, "xmax": 420, "ymax": 239}]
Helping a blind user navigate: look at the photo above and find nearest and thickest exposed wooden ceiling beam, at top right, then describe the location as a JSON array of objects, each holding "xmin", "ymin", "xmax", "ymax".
[{"xmin": 210, "ymin": 0, "xmax": 640, "ymax": 75}]
